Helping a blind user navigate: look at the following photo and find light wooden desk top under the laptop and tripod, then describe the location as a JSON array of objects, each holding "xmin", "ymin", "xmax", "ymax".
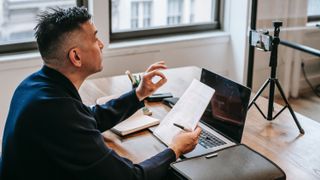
[{"xmin": 80, "ymin": 67, "xmax": 320, "ymax": 180}]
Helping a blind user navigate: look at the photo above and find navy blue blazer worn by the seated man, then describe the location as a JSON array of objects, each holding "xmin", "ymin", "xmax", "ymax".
[{"xmin": 1, "ymin": 66, "xmax": 175, "ymax": 180}]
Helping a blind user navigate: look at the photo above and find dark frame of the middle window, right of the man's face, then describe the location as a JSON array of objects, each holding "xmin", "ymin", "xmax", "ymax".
[{"xmin": 109, "ymin": 0, "xmax": 224, "ymax": 43}]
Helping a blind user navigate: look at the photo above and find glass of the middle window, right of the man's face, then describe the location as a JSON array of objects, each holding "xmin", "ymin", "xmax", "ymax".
[{"xmin": 111, "ymin": 0, "xmax": 216, "ymax": 33}]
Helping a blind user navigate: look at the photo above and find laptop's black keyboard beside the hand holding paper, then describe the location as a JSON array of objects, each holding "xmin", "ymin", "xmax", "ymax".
[{"xmin": 198, "ymin": 129, "xmax": 226, "ymax": 149}]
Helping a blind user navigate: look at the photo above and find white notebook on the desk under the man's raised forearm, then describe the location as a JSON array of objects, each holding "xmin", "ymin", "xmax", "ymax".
[{"xmin": 96, "ymin": 95, "xmax": 160, "ymax": 136}]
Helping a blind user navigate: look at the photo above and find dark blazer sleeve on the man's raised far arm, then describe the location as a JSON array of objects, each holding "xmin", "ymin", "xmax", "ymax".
[{"xmin": 91, "ymin": 89, "xmax": 144, "ymax": 132}]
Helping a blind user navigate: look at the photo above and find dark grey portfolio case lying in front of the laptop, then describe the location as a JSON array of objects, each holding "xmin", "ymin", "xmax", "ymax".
[{"xmin": 171, "ymin": 144, "xmax": 286, "ymax": 180}]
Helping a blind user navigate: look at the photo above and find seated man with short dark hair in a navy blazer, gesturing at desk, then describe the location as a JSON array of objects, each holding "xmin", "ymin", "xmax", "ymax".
[{"xmin": 1, "ymin": 7, "xmax": 201, "ymax": 180}]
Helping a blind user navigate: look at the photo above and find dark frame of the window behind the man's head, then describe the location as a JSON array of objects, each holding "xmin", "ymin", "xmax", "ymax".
[{"xmin": 0, "ymin": 0, "xmax": 88, "ymax": 55}]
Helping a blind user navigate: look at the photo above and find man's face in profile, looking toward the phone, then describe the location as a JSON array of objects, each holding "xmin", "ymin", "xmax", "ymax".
[{"xmin": 79, "ymin": 21, "xmax": 104, "ymax": 75}]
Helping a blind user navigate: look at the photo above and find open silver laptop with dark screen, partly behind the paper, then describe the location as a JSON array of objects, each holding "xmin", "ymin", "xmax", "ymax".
[{"xmin": 183, "ymin": 69, "xmax": 251, "ymax": 158}]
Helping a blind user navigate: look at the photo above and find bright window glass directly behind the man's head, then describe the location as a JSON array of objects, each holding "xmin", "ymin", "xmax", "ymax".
[{"xmin": 0, "ymin": 0, "xmax": 76, "ymax": 45}]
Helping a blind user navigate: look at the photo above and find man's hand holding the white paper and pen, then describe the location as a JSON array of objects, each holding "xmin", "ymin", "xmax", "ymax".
[{"xmin": 169, "ymin": 127, "xmax": 201, "ymax": 159}]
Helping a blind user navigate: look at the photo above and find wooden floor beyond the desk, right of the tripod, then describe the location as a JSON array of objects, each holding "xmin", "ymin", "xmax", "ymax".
[{"xmin": 276, "ymin": 92, "xmax": 320, "ymax": 123}]
